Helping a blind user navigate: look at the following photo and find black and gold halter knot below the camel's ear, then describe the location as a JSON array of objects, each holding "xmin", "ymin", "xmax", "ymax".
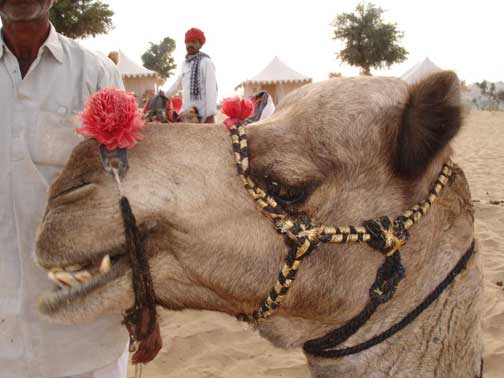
[{"xmin": 364, "ymin": 216, "xmax": 409, "ymax": 256}]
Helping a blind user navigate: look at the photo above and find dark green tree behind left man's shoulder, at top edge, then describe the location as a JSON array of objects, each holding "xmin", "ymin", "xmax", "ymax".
[{"xmin": 49, "ymin": 0, "xmax": 114, "ymax": 38}]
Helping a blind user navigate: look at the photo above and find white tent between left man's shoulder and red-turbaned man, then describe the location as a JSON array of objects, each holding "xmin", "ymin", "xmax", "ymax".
[{"xmin": 117, "ymin": 50, "xmax": 159, "ymax": 103}]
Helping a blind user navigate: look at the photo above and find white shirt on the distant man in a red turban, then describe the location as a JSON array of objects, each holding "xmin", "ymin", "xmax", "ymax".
[{"xmin": 165, "ymin": 57, "xmax": 217, "ymax": 122}]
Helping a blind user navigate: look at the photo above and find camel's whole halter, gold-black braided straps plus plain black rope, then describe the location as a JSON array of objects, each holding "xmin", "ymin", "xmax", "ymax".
[{"xmin": 228, "ymin": 122, "xmax": 475, "ymax": 364}]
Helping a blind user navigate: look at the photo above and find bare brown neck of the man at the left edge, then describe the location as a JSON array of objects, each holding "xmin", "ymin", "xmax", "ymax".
[{"xmin": 2, "ymin": 18, "xmax": 51, "ymax": 77}]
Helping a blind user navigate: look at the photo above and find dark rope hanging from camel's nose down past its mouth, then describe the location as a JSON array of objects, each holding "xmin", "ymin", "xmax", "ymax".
[{"xmin": 119, "ymin": 197, "xmax": 156, "ymax": 341}]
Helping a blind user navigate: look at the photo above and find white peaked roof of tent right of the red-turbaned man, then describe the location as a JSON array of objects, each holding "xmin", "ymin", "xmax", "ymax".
[{"xmin": 236, "ymin": 56, "xmax": 312, "ymax": 89}]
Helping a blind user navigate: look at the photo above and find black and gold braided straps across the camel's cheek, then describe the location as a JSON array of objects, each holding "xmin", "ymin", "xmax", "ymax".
[{"xmin": 230, "ymin": 123, "xmax": 453, "ymax": 322}]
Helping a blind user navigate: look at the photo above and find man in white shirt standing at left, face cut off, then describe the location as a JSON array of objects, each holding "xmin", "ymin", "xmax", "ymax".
[{"xmin": 0, "ymin": 0, "xmax": 128, "ymax": 378}]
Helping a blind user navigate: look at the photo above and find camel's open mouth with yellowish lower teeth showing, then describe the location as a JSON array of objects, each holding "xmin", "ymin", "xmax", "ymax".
[{"xmin": 39, "ymin": 254, "xmax": 129, "ymax": 316}]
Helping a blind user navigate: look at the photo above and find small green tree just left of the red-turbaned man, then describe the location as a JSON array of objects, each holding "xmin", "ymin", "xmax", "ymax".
[{"xmin": 142, "ymin": 37, "xmax": 177, "ymax": 81}]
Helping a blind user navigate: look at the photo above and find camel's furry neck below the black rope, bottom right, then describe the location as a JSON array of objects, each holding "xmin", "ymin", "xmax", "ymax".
[{"xmin": 307, "ymin": 245, "xmax": 482, "ymax": 378}]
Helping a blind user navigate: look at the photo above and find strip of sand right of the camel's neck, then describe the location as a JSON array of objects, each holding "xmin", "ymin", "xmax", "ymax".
[{"xmin": 454, "ymin": 112, "xmax": 504, "ymax": 378}]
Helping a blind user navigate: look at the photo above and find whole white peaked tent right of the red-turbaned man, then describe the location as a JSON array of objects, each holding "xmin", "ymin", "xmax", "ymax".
[{"xmin": 235, "ymin": 56, "xmax": 312, "ymax": 104}]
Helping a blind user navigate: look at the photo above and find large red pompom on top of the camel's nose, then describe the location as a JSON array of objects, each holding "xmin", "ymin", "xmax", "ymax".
[{"xmin": 77, "ymin": 88, "xmax": 144, "ymax": 151}]
